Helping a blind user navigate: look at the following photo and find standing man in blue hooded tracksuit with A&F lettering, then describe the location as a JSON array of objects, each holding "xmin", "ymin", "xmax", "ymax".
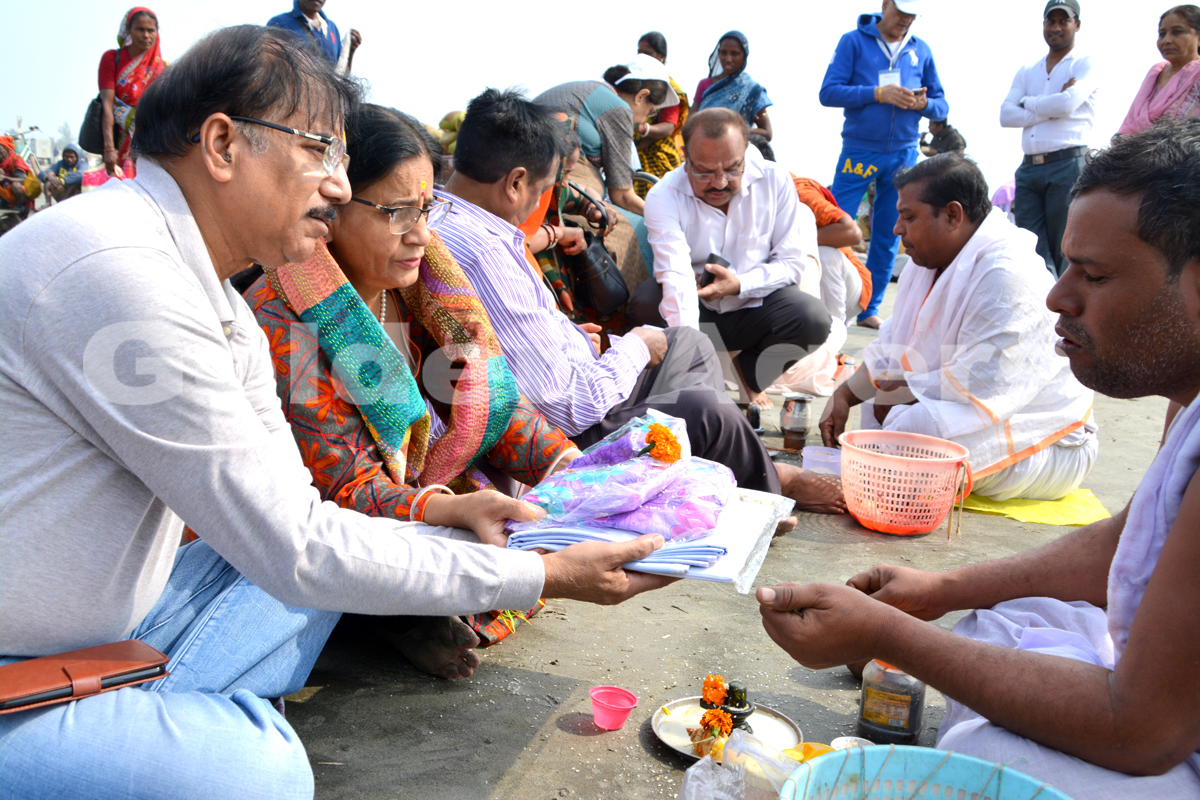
[{"xmin": 821, "ymin": 0, "xmax": 949, "ymax": 327}]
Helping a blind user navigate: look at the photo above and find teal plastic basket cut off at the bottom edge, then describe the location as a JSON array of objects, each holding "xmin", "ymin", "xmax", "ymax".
[{"xmin": 779, "ymin": 745, "xmax": 1070, "ymax": 800}]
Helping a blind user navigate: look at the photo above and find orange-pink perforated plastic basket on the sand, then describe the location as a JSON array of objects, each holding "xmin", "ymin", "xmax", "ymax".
[{"xmin": 838, "ymin": 431, "xmax": 972, "ymax": 536}]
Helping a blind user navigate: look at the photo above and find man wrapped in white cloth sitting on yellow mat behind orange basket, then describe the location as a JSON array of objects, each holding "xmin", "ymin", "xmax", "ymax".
[{"xmin": 821, "ymin": 152, "xmax": 1099, "ymax": 500}]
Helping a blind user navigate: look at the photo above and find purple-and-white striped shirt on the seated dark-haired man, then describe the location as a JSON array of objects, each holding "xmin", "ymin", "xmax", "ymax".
[{"xmin": 438, "ymin": 192, "xmax": 650, "ymax": 437}]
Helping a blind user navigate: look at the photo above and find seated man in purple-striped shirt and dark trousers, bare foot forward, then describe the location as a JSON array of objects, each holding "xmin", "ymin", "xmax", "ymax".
[{"xmin": 438, "ymin": 89, "xmax": 846, "ymax": 513}]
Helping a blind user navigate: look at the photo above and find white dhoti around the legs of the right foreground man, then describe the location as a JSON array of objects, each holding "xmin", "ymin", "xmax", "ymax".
[{"xmin": 937, "ymin": 597, "xmax": 1200, "ymax": 800}]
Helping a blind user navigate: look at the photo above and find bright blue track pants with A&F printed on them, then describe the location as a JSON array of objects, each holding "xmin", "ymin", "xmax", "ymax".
[{"xmin": 829, "ymin": 146, "xmax": 917, "ymax": 319}]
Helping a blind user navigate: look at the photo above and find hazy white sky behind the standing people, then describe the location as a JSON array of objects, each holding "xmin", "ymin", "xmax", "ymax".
[{"xmin": 7, "ymin": 0, "xmax": 1174, "ymax": 188}]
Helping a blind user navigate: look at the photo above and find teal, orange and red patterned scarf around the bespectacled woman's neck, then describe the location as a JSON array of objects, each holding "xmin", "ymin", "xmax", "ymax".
[{"xmin": 266, "ymin": 234, "xmax": 520, "ymax": 486}]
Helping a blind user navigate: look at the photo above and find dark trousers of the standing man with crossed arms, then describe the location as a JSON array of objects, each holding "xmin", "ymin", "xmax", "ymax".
[{"xmin": 1013, "ymin": 156, "xmax": 1085, "ymax": 278}]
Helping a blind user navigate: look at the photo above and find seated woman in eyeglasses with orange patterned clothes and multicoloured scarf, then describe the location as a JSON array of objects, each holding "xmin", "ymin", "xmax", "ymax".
[{"xmin": 246, "ymin": 106, "xmax": 578, "ymax": 678}]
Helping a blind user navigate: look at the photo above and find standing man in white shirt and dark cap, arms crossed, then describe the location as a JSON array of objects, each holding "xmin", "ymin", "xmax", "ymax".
[{"xmin": 1000, "ymin": 0, "xmax": 1097, "ymax": 277}]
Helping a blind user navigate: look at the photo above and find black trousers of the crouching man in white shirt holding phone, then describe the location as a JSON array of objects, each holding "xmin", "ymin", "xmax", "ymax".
[{"xmin": 626, "ymin": 281, "xmax": 832, "ymax": 392}]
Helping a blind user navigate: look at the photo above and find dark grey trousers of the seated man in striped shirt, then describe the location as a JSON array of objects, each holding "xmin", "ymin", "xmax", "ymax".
[{"xmin": 571, "ymin": 326, "xmax": 777, "ymax": 494}]
